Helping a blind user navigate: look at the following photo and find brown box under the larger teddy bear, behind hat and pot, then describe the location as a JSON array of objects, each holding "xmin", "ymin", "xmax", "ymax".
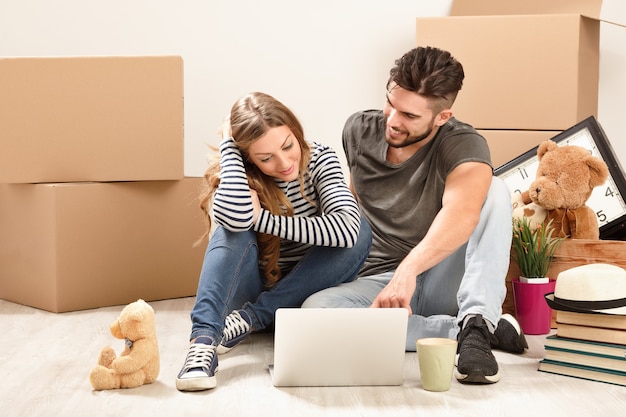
[{"xmin": 502, "ymin": 239, "xmax": 626, "ymax": 327}]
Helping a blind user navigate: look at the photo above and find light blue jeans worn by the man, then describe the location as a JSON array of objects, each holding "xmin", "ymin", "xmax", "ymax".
[{"xmin": 302, "ymin": 177, "xmax": 511, "ymax": 351}]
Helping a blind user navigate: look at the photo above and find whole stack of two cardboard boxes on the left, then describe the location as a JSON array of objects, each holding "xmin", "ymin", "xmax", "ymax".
[{"xmin": 0, "ymin": 56, "xmax": 204, "ymax": 312}]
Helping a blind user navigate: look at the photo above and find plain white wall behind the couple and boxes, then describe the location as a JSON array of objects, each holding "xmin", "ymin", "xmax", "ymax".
[{"xmin": 0, "ymin": 0, "xmax": 626, "ymax": 176}]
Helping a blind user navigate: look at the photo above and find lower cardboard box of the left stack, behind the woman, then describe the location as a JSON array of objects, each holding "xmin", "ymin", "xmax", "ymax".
[{"xmin": 0, "ymin": 178, "xmax": 205, "ymax": 312}]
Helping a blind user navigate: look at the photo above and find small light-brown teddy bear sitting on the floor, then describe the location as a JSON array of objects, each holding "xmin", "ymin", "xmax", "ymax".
[{"xmin": 89, "ymin": 299, "xmax": 160, "ymax": 391}]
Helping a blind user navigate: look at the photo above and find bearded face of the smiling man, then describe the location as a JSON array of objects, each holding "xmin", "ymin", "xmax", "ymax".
[{"xmin": 383, "ymin": 83, "xmax": 438, "ymax": 148}]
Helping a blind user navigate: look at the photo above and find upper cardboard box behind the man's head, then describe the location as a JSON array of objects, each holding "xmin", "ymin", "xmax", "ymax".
[{"xmin": 416, "ymin": 14, "xmax": 600, "ymax": 130}]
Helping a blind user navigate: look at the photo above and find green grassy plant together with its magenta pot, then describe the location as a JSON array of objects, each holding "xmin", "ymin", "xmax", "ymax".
[{"xmin": 511, "ymin": 218, "xmax": 563, "ymax": 334}]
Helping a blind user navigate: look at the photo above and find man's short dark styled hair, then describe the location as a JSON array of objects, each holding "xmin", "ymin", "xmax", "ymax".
[{"xmin": 387, "ymin": 46, "xmax": 465, "ymax": 113}]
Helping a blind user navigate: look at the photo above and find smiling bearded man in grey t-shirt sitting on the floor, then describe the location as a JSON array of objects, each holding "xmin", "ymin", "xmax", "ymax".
[{"xmin": 303, "ymin": 47, "xmax": 527, "ymax": 384}]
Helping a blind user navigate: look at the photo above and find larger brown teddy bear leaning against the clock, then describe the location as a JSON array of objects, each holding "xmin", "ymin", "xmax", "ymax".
[{"xmin": 513, "ymin": 140, "xmax": 609, "ymax": 239}]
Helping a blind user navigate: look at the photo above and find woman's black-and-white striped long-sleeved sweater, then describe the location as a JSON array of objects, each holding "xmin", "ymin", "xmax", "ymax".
[{"xmin": 212, "ymin": 139, "xmax": 360, "ymax": 270}]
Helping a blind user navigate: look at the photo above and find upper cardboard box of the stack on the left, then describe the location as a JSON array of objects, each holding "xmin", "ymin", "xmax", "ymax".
[{"xmin": 0, "ymin": 56, "xmax": 184, "ymax": 183}]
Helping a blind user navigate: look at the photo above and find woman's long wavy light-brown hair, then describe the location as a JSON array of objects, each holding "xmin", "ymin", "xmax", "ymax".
[{"xmin": 200, "ymin": 92, "xmax": 311, "ymax": 288}]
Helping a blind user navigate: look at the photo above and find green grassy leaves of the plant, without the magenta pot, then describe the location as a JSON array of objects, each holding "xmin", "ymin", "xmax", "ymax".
[{"xmin": 511, "ymin": 217, "xmax": 563, "ymax": 284}]
